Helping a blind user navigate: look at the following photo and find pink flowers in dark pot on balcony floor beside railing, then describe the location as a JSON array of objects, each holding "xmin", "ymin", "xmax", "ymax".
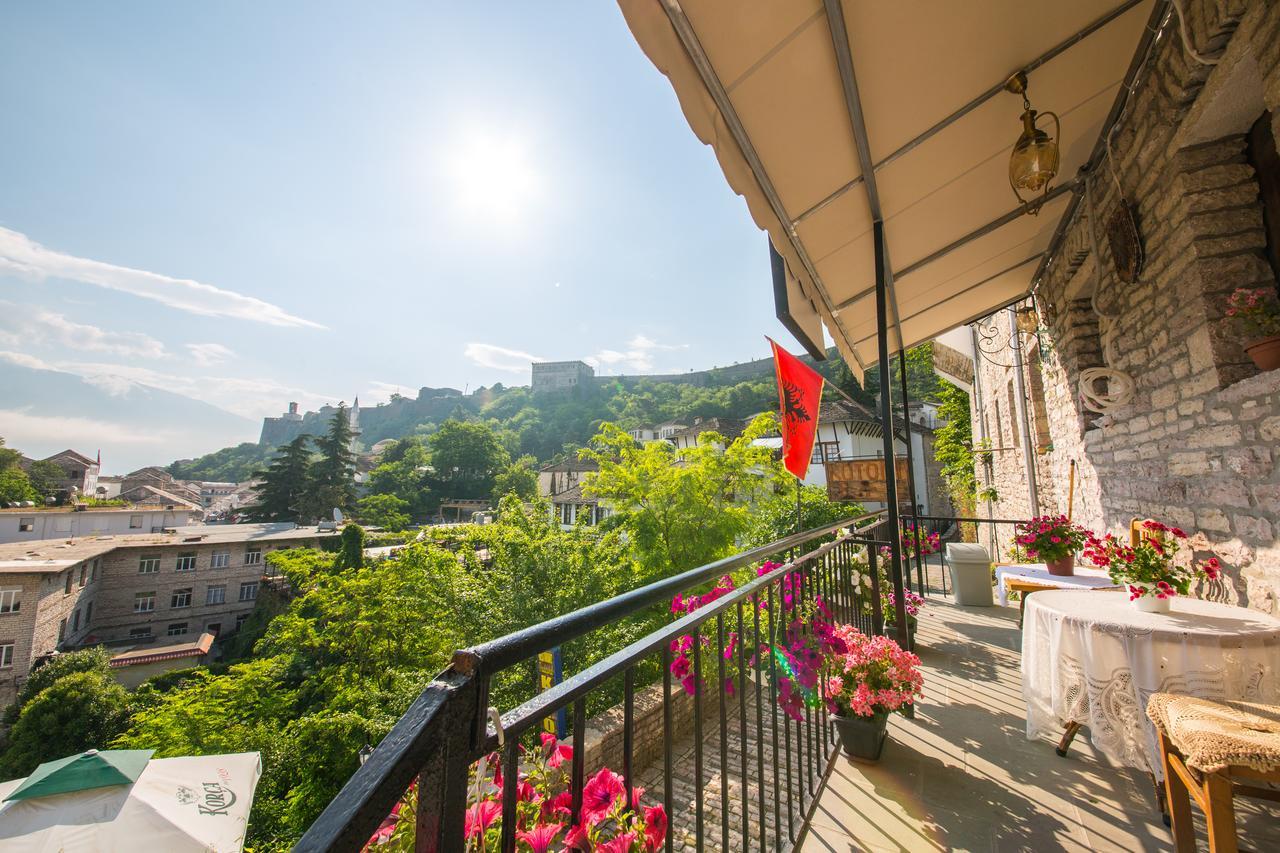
[{"xmin": 826, "ymin": 625, "xmax": 924, "ymax": 762}]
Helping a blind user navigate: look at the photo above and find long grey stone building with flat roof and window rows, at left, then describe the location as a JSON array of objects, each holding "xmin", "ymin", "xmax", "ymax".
[{"xmin": 0, "ymin": 524, "xmax": 337, "ymax": 707}]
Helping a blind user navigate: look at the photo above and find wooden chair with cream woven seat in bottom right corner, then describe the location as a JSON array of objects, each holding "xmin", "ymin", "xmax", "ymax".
[{"xmin": 1147, "ymin": 693, "xmax": 1280, "ymax": 853}]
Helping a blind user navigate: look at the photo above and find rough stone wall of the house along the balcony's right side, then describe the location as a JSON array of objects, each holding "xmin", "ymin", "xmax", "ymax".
[{"xmin": 974, "ymin": 0, "xmax": 1280, "ymax": 613}]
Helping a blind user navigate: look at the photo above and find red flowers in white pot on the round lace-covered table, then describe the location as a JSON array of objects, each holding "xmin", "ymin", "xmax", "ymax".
[{"xmin": 1084, "ymin": 520, "xmax": 1222, "ymax": 613}]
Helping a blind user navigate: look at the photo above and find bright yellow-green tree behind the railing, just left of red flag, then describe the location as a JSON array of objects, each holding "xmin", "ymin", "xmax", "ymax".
[{"xmin": 581, "ymin": 415, "xmax": 785, "ymax": 578}]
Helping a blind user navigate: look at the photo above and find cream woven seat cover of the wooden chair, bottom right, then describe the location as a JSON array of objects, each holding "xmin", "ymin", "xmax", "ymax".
[{"xmin": 1147, "ymin": 693, "xmax": 1280, "ymax": 774}]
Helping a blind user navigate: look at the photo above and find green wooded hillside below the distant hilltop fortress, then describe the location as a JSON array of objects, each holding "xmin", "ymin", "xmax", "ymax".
[{"xmin": 169, "ymin": 346, "xmax": 937, "ymax": 480}]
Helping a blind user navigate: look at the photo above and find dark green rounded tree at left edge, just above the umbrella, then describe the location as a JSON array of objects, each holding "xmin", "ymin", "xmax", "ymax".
[{"xmin": 0, "ymin": 670, "xmax": 129, "ymax": 779}]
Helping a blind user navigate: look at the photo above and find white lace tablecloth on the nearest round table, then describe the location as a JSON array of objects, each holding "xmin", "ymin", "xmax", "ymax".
[{"xmin": 1023, "ymin": 589, "xmax": 1280, "ymax": 777}]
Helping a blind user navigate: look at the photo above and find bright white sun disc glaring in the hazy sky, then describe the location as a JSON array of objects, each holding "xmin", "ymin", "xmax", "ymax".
[{"xmin": 449, "ymin": 134, "xmax": 539, "ymax": 220}]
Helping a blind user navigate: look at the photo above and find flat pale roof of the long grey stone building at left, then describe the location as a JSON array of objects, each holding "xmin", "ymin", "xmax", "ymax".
[{"xmin": 0, "ymin": 521, "xmax": 338, "ymax": 563}]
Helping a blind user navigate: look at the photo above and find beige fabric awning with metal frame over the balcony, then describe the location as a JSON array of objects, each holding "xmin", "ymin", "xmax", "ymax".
[{"xmin": 620, "ymin": 0, "xmax": 1165, "ymax": 377}]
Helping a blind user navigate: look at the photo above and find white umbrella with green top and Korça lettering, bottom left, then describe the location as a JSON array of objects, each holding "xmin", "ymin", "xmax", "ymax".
[{"xmin": 0, "ymin": 751, "xmax": 262, "ymax": 853}]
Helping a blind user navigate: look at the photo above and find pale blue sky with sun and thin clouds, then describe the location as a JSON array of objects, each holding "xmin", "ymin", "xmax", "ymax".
[{"xmin": 0, "ymin": 0, "xmax": 785, "ymax": 461}]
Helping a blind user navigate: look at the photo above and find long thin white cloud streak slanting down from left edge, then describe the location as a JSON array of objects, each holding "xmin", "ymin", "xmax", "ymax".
[{"xmin": 0, "ymin": 228, "xmax": 325, "ymax": 329}]
